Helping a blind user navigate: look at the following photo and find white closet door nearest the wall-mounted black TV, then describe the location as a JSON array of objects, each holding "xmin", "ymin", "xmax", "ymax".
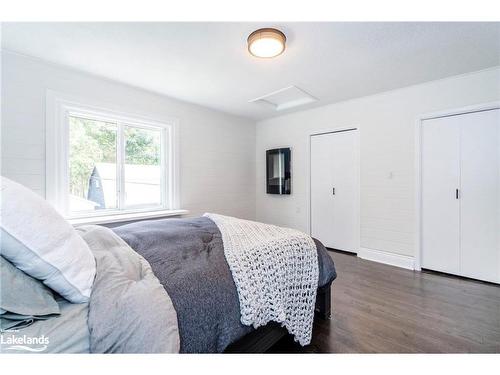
[{"xmin": 311, "ymin": 131, "xmax": 359, "ymax": 252}]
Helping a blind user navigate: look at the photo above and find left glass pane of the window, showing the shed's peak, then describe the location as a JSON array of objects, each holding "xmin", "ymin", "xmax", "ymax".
[{"xmin": 69, "ymin": 116, "xmax": 118, "ymax": 214}]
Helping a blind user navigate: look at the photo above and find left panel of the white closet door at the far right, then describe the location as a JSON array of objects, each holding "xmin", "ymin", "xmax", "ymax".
[{"xmin": 422, "ymin": 117, "xmax": 460, "ymax": 274}]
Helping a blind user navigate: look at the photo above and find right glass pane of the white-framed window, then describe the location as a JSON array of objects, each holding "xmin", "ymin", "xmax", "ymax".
[{"xmin": 124, "ymin": 126, "xmax": 162, "ymax": 208}]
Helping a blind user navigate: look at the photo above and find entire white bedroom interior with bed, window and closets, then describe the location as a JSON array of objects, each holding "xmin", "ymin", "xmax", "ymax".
[{"xmin": 0, "ymin": 0, "xmax": 500, "ymax": 374}]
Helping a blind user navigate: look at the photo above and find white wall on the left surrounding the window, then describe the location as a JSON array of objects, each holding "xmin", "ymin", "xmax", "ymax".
[{"xmin": 1, "ymin": 51, "xmax": 255, "ymax": 218}]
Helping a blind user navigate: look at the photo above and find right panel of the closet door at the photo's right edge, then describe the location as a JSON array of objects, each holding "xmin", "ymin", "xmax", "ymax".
[{"xmin": 455, "ymin": 110, "xmax": 500, "ymax": 282}]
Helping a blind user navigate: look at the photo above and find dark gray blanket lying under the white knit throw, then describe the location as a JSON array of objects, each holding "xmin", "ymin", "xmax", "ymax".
[{"xmin": 113, "ymin": 217, "xmax": 336, "ymax": 353}]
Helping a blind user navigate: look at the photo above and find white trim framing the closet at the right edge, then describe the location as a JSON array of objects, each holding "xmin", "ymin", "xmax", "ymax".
[{"xmin": 414, "ymin": 101, "xmax": 500, "ymax": 271}]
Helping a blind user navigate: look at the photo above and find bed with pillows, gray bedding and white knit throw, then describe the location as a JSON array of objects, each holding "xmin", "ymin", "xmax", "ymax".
[{"xmin": 0, "ymin": 181, "xmax": 336, "ymax": 353}]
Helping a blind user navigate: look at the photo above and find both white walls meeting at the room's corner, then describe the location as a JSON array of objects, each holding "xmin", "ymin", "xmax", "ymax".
[{"xmin": 1, "ymin": 51, "xmax": 500, "ymax": 262}]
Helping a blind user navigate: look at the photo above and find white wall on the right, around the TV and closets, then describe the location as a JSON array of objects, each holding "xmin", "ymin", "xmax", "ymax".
[{"xmin": 256, "ymin": 68, "xmax": 500, "ymax": 256}]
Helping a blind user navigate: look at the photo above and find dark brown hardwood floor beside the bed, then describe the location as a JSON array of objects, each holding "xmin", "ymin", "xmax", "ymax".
[{"xmin": 271, "ymin": 252, "xmax": 500, "ymax": 353}]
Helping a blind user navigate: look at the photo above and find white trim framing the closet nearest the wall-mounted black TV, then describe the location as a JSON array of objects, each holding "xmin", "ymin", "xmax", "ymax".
[{"xmin": 307, "ymin": 126, "xmax": 361, "ymax": 254}]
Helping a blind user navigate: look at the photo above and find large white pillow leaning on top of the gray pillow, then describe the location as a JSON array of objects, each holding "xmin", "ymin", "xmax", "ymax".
[{"xmin": 0, "ymin": 176, "xmax": 96, "ymax": 303}]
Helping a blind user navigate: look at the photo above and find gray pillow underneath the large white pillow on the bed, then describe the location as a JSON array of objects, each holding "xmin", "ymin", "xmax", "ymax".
[{"xmin": 0, "ymin": 256, "xmax": 60, "ymax": 319}]
